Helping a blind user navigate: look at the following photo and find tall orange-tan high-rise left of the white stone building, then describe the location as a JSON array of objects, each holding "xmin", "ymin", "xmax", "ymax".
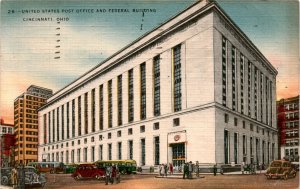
[{"xmin": 14, "ymin": 85, "xmax": 52, "ymax": 164}]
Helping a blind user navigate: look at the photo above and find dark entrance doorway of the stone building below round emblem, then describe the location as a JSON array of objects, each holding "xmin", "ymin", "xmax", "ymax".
[{"xmin": 171, "ymin": 143, "xmax": 185, "ymax": 167}]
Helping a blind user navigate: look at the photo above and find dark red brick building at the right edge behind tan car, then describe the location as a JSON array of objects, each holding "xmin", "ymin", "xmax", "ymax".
[{"xmin": 277, "ymin": 95, "xmax": 300, "ymax": 162}]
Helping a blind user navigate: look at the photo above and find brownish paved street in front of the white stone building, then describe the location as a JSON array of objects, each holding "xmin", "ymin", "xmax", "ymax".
[{"xmin": 27, "ymin": 174, "xmax": 299, "ymax": 189}]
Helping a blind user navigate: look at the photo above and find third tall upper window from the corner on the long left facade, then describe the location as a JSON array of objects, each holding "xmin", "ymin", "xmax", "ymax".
[{"xmin": 140, "ymin": 63, "xmax": 146, "ymax": 120}]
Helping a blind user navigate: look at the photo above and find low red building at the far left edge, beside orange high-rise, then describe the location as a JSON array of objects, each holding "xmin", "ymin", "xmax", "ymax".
[{"xmin": 0, "ymin": 119, "xmax": 15, "ymax": 167}]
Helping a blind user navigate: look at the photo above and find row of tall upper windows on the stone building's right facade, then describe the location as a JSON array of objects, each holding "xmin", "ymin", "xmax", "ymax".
[{"xmin": 222, "ymin": 36, "xmax": 273, "ymax": 125}]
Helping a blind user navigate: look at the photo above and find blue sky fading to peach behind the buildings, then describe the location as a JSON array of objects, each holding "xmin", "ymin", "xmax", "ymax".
[{"xmin": 0, "ymin": 0, "xmax": 299, "ymax": 122}]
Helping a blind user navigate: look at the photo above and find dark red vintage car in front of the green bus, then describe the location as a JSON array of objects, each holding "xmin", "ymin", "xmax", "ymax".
[{"xmin": 72, "ymin": 163, "xmax": 105, "ymax": 180}]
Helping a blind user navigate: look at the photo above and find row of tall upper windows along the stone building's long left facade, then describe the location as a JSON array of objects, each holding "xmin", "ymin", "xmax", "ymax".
[{"xmin": 43, "ymin": 45, "xmax": 182, "ymax": 143}]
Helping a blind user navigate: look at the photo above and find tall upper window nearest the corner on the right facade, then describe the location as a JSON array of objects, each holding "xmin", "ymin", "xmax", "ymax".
[{"xmin": 222, "ymin": 36, "xmax": 227, "ymax": 106}]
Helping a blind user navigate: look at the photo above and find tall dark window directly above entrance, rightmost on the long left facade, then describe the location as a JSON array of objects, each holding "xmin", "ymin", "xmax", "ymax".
[{"xmin": 172, "ymin": 45, "xmax": 181, "ymax": 112}]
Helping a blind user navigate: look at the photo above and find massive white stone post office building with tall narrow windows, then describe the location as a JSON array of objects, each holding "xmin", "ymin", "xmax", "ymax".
[{"xmin": 38, "ymin": 1, "xmax": 278, "ymax": 166}]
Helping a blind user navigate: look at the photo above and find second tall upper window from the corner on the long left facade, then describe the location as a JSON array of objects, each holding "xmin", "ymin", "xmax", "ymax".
[{"xmin": 153, "ymin": 56, "xmax": 160, "ymax": 116}]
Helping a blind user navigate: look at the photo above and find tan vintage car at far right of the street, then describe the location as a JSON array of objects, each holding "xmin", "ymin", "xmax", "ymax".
[{"xmin": 265, "ymin": 160, "xmax": 297, "ymax": 180}]
